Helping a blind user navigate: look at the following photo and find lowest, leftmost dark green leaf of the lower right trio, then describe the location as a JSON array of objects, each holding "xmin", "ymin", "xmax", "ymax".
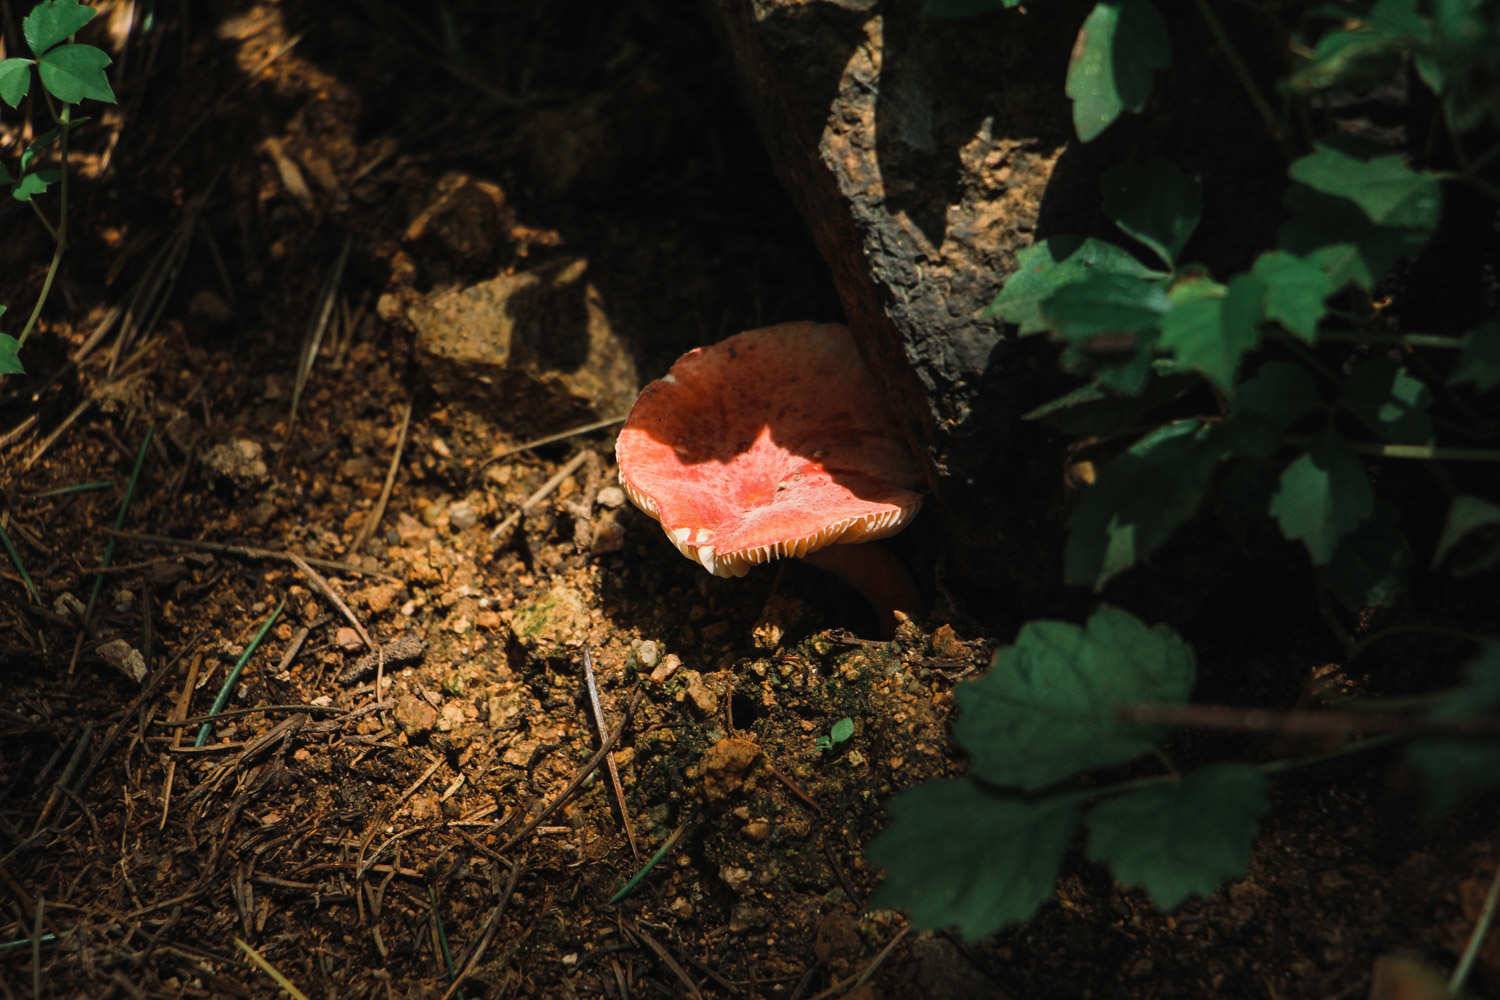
[{"xmin": 866, "ymin": 778, "xmax": 1079, "ymax": 940}]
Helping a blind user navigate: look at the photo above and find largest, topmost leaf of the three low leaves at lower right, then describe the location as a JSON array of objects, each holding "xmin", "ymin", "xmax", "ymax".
[{"xmin": 954, "ymin": 606, "xmax": 1196, "ymax": 792}]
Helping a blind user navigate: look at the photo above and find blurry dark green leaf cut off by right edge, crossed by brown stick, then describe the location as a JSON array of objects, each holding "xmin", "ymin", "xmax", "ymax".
[{"xmin": 1407, "ymin": 639, "xmax": 1500, "ymax": 816}]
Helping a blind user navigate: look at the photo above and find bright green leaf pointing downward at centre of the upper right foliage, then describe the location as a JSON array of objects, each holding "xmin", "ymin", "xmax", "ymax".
[{"xmin": 1161, "ymin": 274, "xmax": 1266, "ymax": 391}]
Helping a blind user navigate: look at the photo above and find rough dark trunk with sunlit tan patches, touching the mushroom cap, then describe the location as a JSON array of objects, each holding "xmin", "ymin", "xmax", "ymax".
[{"xmin": 702, "ymin": 0, "xmax": 1097, "ymax": 593}]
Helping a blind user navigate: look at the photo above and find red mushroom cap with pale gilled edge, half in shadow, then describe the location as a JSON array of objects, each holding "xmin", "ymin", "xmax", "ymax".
[{"xmin": 615, "ymin": 322, "xmax": 921, "ymax": 576}]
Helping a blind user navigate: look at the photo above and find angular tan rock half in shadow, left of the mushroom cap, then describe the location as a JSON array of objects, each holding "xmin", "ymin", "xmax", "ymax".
[{"xmin": 407, "ymin": 258, "xmax": 639, "ymax": 427}]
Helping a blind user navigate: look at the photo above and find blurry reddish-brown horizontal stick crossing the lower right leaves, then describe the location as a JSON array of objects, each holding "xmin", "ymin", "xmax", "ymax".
[{"xmin": 1116, "ymin": 705, "xmax": 1500, "ymax": 736}]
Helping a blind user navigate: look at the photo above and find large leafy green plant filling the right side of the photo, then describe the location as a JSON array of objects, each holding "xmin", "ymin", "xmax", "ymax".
[{"xmin": 870, "ymin": 0, "xmax": 1500, "ymax": 959}]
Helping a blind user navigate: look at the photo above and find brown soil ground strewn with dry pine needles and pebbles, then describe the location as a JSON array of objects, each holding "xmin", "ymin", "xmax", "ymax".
[{"xmin": 0, "ymin": 0, "xmax": 1500, "ymax": 1000}]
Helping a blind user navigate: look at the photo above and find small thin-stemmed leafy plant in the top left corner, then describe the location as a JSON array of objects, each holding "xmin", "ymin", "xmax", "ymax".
[{"xmin": 0, "ymin": 0, "xmax": 114, "ymax": 375}]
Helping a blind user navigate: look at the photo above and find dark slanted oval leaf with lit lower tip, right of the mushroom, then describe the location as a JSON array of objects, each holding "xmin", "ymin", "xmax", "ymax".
[{"xmin": 1064, "ymin": 420, "xmax": 1223, "ymax": 591}]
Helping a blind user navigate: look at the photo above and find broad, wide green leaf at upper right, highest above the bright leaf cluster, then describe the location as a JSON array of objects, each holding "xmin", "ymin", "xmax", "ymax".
[{"xmin": 1287, "ymin": 144, "xmax": 1443, "ymax": 231}]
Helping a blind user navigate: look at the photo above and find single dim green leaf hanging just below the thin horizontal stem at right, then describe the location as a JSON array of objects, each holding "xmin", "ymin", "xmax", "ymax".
[{"xmin": 1271, "ymin": 430, "xmax": 1376, "ymax": 565}]
